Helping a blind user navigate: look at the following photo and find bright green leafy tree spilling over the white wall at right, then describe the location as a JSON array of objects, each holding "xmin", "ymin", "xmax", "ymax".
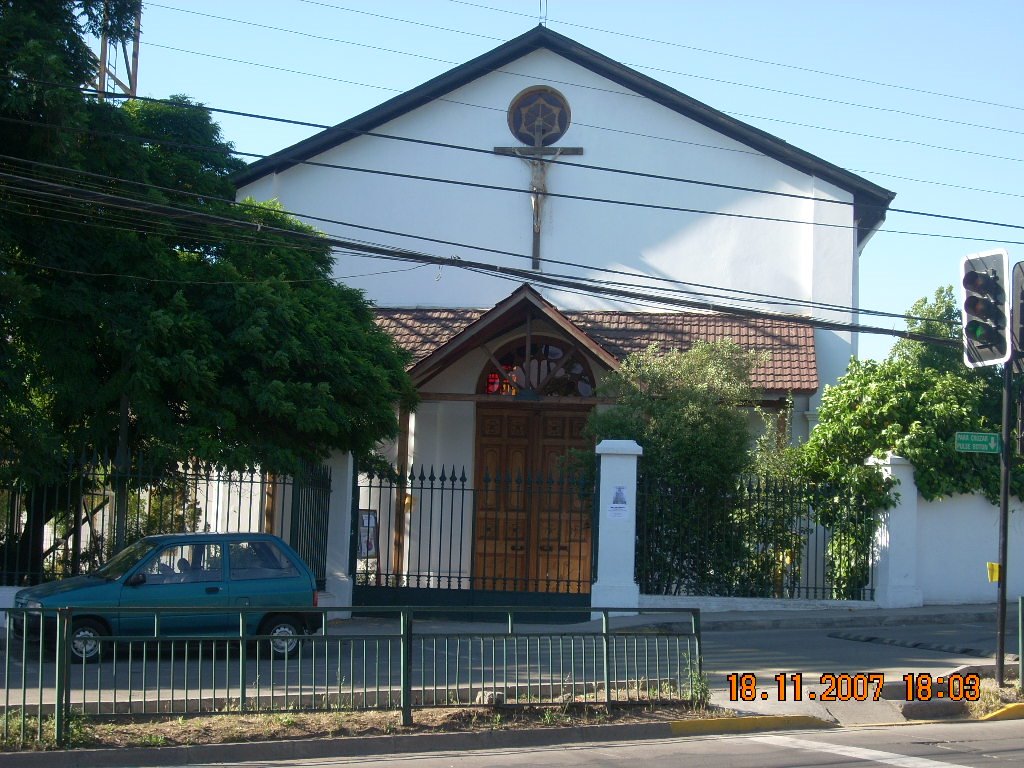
[{"xmin": 803, "ymin": 287, "xmax": 1001, "ymax": 509}]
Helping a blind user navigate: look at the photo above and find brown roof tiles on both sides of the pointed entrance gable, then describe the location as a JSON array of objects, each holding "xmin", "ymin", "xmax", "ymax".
[{"xmin": 376, "ymin": 307, "xmax": 818, "ymax": 393}]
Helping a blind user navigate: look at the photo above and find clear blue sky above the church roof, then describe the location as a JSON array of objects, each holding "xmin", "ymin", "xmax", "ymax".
[{"xmin": 121, "ymin": 0, "xmax": 1024, "ymax": 357}]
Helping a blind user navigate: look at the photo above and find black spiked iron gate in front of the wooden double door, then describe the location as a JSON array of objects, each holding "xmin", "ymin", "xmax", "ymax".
[{"xmin": 352, "ymin": 467, "xmax": 594, "ymax": 594}]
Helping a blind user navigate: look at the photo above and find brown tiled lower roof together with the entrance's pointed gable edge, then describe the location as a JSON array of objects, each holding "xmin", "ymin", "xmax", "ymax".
[{"xmin": 375, "ymin": 286, "xmax": 819, "ymax": 394}]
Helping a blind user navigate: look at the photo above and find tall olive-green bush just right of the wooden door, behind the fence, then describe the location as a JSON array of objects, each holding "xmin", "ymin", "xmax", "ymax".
[{"xmin": 589, "ymin": 341, "xmax": 770, "ymax": 595}]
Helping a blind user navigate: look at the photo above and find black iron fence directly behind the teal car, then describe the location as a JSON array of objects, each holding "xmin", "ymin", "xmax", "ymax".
[{"xmin": 0, "ymin": 456, "xmax": 331, "ymax": 586}]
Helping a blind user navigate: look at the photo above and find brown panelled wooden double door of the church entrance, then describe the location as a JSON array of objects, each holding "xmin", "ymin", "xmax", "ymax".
[{"xmin": 473, "ymin": 403, "xmax": 593, "ymax": 594}]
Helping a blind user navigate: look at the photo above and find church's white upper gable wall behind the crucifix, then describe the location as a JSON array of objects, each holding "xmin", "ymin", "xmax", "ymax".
[{"xmin": 240, "ymin": 50, "xmax": 856, "ymax": 409}]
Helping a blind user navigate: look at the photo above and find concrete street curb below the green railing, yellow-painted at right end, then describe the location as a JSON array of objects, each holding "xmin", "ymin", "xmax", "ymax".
[{"xmin": 0, "ymin": 715, "xmax": 837, "ymax": 768}]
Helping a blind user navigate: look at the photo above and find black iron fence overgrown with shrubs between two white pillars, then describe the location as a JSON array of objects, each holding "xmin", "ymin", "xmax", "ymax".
[{"xmin": 636, "ymin": 478, "xmax": 878, "ymax": 600}]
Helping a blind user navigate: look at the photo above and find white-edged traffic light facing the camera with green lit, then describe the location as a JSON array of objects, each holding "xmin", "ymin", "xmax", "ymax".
[{"xmin": 963, "ymin": 249, "xmax": 1013, "ymax": 368}]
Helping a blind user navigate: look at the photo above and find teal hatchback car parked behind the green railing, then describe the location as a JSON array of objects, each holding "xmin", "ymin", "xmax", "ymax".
[{"xmin": 12, "ymin": 534, "xmax": 319, "ymax": 662}]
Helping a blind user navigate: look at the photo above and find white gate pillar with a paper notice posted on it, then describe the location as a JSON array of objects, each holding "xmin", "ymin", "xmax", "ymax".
[{"xmin": 591, "ymin": 440, "xmax": 643, "ymax": 608}]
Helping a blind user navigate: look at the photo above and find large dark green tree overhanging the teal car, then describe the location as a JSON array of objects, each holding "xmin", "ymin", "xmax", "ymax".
[{"xmin": 0, "ymin": 0, "xmax": 415, "ymax": 577}]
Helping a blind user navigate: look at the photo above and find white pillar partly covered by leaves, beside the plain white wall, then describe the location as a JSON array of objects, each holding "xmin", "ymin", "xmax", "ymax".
[{"xmin": 867, "ymin": 454, "xmax": 925, "ymax": 608}]
